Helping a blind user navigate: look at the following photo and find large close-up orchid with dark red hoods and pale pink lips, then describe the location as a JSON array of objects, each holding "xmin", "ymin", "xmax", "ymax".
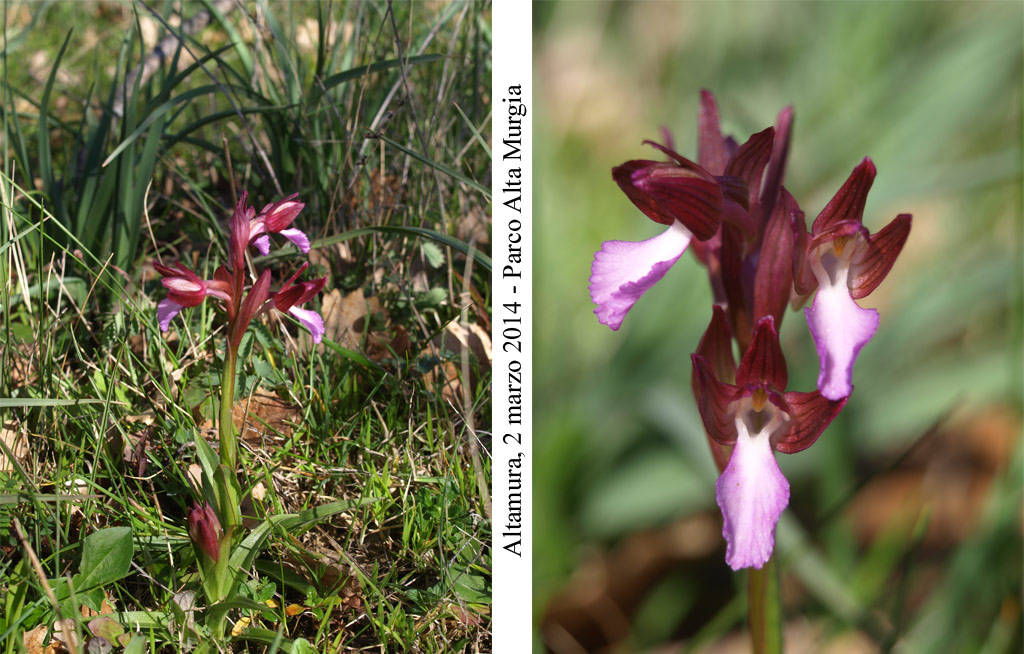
[{"xmin": 590, "ymin": 91, "xmax": 910, "ymax": 651}]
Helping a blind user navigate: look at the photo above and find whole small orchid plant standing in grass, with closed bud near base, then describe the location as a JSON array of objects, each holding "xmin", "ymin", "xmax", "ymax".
[{"xmin": 155, "ymin": 192, "xmax": 327, "ymax": 640}]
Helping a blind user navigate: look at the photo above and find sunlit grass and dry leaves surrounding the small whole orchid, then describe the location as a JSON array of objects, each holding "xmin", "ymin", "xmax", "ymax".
[{"xmin": 0, "ymin": 3, "xmax": 490, "ymax": 652}]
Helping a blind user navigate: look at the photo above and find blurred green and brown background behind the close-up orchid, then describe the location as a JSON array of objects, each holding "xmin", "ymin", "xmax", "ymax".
[{"xmin": 534, "ymin": 2, "xmax": 1024, "ymax": 652}]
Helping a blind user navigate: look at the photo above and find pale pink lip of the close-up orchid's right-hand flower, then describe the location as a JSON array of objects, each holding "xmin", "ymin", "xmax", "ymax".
[{"xmin": 804, "ymin": 275, "xmax": 879, "ymax": 400}]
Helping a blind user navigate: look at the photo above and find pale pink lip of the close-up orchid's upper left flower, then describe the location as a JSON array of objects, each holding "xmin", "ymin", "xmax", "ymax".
[{"xmin": 590, "ymin": 220, "xmax": 693, "ymax": 330}]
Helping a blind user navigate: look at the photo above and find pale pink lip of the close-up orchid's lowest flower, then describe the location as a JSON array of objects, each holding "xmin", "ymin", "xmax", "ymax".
[{"xmin": 715, "ymin": 420, "xmax": 790, "ymax": 570}]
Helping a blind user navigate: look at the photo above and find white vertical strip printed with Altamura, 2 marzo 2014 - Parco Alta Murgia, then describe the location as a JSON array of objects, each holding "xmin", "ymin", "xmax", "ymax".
[{"xmin": 490, "ymin": 0, "xmax": 534, "ymax": 654}]
